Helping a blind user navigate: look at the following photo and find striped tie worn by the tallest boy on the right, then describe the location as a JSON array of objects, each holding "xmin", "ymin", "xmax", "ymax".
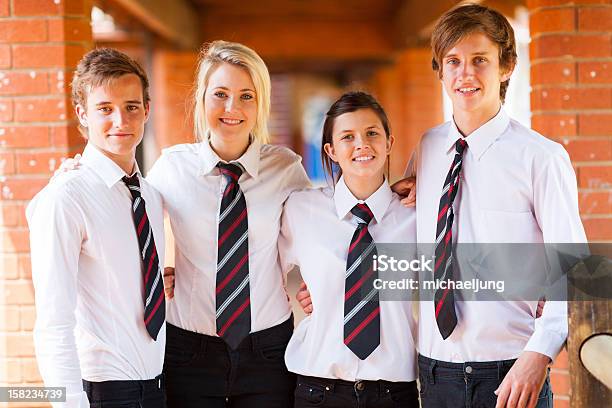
[{"xmin": 434, "ymin": 139, "xmax": 467, "ymax": 339}]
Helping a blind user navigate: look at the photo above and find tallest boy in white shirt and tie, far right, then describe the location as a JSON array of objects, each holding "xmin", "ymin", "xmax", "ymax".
[{"xmin": 416, "ymin": 4, "xmax": 586, "ymax": 408}]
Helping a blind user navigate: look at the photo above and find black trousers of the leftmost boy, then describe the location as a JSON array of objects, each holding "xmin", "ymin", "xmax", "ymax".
[{"xmin": 83, "ymin": 374, "xmax": 166, "ymax": 408}]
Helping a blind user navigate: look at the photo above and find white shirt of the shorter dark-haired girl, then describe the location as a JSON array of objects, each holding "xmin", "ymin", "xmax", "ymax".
[{"xmin": 279, "ymin": 178, "xmax": 416, "ymax": 381}]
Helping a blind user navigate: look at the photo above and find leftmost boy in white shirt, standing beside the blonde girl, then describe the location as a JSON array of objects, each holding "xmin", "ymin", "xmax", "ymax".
[{"xmin": 27, "ymin": 49, "xmax": 166, "ymax": 408}]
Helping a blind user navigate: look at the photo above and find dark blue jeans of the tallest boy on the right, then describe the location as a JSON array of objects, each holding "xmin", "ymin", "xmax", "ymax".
[{"xmin": 419, "ymin": 355, "xmax": 553, "ymax": 408}]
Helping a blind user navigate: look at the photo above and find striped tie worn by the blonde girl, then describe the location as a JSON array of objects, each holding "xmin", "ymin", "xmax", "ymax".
[{"xmin": 216, "ymin": 162, "xmax": 251, "ymax": 350}]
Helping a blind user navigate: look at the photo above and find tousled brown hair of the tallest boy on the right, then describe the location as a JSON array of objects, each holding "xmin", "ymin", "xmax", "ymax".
[{"xmin": 431, "ymin": 4, "xmax": 516, "ymax": 103}]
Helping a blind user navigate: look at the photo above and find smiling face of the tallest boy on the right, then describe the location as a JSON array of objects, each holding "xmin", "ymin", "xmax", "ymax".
[{"xmin": 442, "ymin": 32, "xmax": 512, "ymax": 121}]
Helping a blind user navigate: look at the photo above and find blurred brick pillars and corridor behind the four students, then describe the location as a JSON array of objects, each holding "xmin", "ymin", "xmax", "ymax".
[{"xmin": 0, "ymin": 0, "xmax": 612, "ymax": 407}]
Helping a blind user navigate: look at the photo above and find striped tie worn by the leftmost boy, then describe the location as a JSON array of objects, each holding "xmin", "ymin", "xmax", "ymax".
[{"xmin": 123, "ymin": 174, "xmax": 166, "ymax": 340}]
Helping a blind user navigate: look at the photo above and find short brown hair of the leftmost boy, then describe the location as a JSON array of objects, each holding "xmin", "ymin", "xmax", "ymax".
[{"xmin": 72, "ymin": 48, "xmax": 151, "ymax": 133}]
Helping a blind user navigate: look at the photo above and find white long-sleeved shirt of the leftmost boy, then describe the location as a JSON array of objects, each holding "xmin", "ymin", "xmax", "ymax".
[{"xmin": 27, "ymin": 145, "xmax": 166, "ymax": 407}]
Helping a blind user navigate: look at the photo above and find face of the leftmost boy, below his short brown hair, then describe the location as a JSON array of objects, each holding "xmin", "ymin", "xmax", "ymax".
[{"xmin": 76, "ymin": 74, "xmax": 149, "ymax": 173}]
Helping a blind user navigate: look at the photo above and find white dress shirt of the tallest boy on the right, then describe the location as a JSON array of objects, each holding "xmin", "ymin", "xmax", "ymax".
[{"xmin": 416, "ymin": 109, "xmax": 586, "ymax": 362}]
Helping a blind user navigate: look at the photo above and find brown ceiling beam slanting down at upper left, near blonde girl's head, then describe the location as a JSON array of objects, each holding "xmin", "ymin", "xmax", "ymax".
[{"xmin": 106, "ymin": 0, "xmax": 200, "ymax": 49}]
